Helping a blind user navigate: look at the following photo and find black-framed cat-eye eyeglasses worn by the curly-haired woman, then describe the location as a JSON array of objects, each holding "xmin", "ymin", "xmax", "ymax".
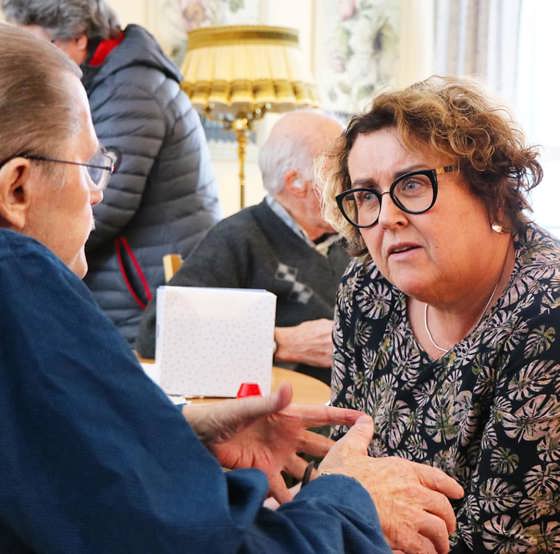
[{"xmin": 336, "ymin": 165, "xmax": 459, "ymax": 228}]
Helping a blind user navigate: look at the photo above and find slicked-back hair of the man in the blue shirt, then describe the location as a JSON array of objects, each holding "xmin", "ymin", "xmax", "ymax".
[{"xmin": 0, "ymin": 23, "xmax": 81, "ymax": 164}]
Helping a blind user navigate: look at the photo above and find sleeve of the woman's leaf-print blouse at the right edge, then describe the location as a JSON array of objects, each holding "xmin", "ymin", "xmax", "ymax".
[{"xmin": 458, "ymin": 308, "xmax": 560, "ymax": 553}]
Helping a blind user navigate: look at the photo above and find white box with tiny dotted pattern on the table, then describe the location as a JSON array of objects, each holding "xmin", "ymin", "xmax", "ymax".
[{"xmin": 156, "ymin": 286, "xmax": 276, "ymax": 397}]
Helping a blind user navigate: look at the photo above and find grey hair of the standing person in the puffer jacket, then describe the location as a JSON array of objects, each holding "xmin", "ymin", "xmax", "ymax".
[{"xmin": 2, "ymin": 0, "xmax": 120, "ymax": 40}]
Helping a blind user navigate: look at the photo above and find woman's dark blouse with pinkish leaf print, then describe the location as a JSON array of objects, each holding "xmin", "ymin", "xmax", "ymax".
[{"xmin": 332, "ymin": 224, "xmax": 560, "ymax": 554}]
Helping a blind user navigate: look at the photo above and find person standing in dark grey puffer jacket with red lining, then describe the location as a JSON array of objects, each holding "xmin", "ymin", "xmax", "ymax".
[{"xmin": 2, "ymin": 0, "xmax": 220, "ymax": 343}]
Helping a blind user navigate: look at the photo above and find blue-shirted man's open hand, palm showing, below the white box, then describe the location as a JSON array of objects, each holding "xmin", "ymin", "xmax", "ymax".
[{"xmin": 183, "ymin": 385, "xmax": 361, "ymax": 503}]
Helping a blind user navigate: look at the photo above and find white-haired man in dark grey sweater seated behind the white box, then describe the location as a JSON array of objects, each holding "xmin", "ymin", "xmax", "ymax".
[{"xmin": 136, "ymin": 111, "xmax": 348, "ymax": 383}]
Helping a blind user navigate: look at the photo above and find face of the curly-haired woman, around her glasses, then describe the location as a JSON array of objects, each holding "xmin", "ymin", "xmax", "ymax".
[{"xmin": 348, "ymin": 128, "xmax": 496, "ymax": 302}]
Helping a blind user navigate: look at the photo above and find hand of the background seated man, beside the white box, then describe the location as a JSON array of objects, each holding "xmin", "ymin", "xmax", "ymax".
[{"xmin": 274, "ymin": 319, "xmax": 333, "ymax": 367}]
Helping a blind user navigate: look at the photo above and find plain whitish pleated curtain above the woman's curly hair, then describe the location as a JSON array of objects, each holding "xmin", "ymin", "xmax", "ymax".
[{"xmin": 434, "ymin": 0, "xmax": 522, "ymax": 102}]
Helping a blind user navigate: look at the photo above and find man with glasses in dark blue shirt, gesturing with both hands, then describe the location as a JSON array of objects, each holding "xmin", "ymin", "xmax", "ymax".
[{"xmin": 0, "ymin": 24, "xmax": 462, "ymax": 554}]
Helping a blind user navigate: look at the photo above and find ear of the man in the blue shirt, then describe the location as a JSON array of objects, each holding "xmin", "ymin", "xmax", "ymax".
[{"xmin": 0, "ymin": 158, "xmax": 31, "ymax": 231}]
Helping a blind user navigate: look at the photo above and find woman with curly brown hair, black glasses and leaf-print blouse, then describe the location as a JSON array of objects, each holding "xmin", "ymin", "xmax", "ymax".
[{"xmin": 325, "ymin": 77, "xmax": 560, "ymax": 553}]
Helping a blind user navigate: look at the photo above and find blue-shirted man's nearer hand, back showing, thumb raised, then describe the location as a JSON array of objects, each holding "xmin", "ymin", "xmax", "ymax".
[{"xmin": 319, "ymin": 416, "xmax": 463, "ymax": 553}]
